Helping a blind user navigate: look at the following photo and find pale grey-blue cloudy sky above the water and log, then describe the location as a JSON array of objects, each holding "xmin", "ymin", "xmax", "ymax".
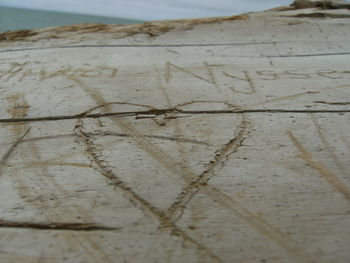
[{"xmin": 0, "ymin": 0, "xmax": 293, "ymax": 21}]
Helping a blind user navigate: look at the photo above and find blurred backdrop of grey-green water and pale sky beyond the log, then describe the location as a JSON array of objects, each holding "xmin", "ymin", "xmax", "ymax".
[{"xmin": 0, "ymin": 0, "xmax": 332, "ymax": 32}]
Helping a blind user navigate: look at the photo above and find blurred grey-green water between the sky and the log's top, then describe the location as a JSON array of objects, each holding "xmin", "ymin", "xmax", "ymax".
[{"xmin": 0, "ymin": 6, "xmax": 144, "ymax": 32}]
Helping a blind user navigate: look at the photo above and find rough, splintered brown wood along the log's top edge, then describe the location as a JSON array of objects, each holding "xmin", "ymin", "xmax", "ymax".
[{"xmin": 0, "ymin": 0, "xmax": 350, "ymax": 43}]
